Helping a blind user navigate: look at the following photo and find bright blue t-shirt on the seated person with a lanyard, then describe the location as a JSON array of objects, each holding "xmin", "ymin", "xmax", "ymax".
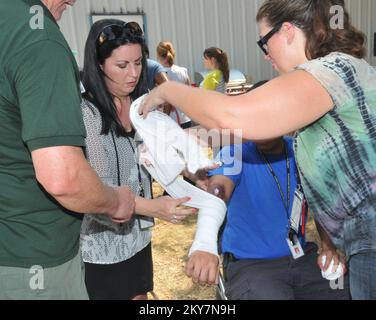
[{"xmin": 209, "ymin": 137, "xmax": 305, "ymax": 259}]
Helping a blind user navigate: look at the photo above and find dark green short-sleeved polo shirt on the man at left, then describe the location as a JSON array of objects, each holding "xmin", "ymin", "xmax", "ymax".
[{"xmin": 0, "ymin": 0, "xmax": 85, "ymax": 268}]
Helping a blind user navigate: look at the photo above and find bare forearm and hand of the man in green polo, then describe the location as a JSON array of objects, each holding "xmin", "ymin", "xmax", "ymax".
[{"xmin": 32, "ymin": 146, "xmax": 135, "ymax": 223}]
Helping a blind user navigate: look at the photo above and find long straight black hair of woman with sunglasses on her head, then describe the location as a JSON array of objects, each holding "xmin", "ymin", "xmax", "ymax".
[{"xmin": 81, "ymin": 19, "xmax": 147, "ymax": 136}]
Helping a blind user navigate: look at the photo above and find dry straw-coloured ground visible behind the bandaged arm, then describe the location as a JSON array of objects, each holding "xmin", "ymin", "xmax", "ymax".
[{"xmin": 150, "ymin": 183, "xmax": 317, "ymax": 300}]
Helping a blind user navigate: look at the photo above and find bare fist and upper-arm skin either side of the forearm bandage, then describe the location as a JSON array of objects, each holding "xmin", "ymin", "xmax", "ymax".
[{"xmin": 185, "ymin": 175, "xmax": 235, "ymax": 285}]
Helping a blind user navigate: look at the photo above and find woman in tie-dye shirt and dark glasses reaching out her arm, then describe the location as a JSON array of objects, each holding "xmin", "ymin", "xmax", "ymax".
[{"xmin": 141, "ymin": 0, "xmax": 376, "ymax": 299}]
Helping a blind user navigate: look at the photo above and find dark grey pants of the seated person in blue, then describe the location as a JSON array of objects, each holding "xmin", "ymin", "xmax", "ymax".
[{"xmin": 224, "ymin": 243, "xmax": 350, "ymax": 300}]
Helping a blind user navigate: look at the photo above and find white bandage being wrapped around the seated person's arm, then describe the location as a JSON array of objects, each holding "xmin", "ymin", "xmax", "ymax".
[{"xmin": 130, "ymin": 97, "xmax": 227, "ymax": 255}]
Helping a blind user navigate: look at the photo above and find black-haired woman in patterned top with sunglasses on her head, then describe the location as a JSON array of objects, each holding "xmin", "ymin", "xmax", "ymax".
[{"xmin": 81, "ymin": 20, "xmax": 196, "ymax": 300}]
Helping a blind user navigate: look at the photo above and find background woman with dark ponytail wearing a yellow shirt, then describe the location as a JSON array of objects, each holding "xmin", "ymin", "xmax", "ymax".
[{"xmin": 200, "ymin": 47, "xmax": 230, "ymax": 93}]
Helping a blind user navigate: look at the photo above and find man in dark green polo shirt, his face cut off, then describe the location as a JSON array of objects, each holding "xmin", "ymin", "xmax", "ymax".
[{"xmin": 0, "ymin": 0, "xmax": 135, "ymax": 299}]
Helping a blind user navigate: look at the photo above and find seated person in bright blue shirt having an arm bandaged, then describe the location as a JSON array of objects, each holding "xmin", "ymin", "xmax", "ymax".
[{"xmin": 186, "ymin": 83, "xmax": 350, "ymax": 300}]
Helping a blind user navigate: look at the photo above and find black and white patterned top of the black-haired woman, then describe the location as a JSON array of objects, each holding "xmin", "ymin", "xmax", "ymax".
[{"xmin": 81, "ymin": 100, "xmax": 151, "ymax": 264}]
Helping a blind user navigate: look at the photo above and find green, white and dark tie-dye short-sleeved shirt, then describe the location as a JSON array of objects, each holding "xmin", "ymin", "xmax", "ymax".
[{"xmin": 295, "ymin": 52, "xmax": 376, "ymax": 256}]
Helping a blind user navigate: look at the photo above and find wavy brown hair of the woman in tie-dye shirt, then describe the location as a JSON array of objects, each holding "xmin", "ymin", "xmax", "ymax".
[{"xmin": 256, "ymin": 0, "xmax": 366, "ymax": 59}]
